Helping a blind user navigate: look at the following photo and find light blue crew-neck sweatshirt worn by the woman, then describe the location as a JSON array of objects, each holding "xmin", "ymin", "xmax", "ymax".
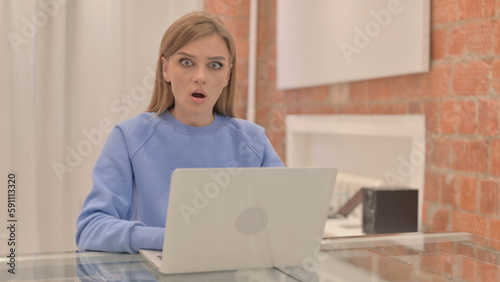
[{"xmin": 76, "ymin": 111, "xmax": 283, "ymax": 253}]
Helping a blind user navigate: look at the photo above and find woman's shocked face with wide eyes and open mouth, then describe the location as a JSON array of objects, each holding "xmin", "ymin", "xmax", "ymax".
[{"xmin": 162, "ymin": 35, "xmax": 232, "ymax": 126}]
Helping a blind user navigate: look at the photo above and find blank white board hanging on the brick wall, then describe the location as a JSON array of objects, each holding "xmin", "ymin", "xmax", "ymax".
[{"xmin": 276, "ymin": 0, "xmax": 430, "ymax": 89}]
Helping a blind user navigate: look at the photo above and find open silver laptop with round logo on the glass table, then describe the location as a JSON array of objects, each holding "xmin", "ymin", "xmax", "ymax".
[{"xmin": 140, "ymin": 167, "xmax": 337, "ymax": 274}]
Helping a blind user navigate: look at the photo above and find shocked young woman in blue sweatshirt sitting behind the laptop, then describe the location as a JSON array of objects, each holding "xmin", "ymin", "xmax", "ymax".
[{"xmin": 76, "ymin": 12, "xmax": 283, "ymax": 253}]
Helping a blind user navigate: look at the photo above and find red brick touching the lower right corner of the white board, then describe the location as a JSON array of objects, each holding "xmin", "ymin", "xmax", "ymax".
[{"xmin": 420, "ymin": 65, "xmax": 451, "ymax": 98}]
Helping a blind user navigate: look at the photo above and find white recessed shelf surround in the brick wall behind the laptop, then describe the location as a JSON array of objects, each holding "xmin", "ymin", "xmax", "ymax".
[{"xmin": 286, "ymin": 115, "xmax": 426, "ymax": 236}]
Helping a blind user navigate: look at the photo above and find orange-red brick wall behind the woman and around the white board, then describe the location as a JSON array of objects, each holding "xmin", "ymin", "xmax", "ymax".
[{"xmin": 205, "ymin": 0, "xmax": 500, "ymax": 239}]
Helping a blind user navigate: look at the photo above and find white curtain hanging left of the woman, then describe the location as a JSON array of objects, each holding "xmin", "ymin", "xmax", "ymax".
[{"xmin": 0, "ymin": 0, "xmax": 203, "ymax": 254}]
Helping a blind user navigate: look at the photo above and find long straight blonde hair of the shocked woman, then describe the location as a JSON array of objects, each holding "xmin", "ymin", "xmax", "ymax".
[{"xmin": 146, "ymin": 11, "xmax": 236, "ymax": 117}]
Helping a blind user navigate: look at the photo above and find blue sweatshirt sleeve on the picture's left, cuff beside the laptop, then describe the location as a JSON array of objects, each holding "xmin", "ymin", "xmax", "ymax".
[{"xmin": 76, "ymin": 127, "xmax": 165, "ymax": 253}]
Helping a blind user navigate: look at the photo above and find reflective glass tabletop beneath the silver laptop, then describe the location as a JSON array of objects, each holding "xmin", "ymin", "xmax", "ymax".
[{"xmin": 0, "ymin": 232, "xmax": 500, "ymax": 282}]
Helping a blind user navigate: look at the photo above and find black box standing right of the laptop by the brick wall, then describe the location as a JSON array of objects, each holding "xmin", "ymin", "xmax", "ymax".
[{"xmin": 362, "ymin": 187, "xmax": 418, "ymax": 234}]
